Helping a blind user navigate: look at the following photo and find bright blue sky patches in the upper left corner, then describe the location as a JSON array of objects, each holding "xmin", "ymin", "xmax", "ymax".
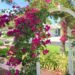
[{"xmin": 0, "ymin": 0, "xmax": 28, "ymax": 10}]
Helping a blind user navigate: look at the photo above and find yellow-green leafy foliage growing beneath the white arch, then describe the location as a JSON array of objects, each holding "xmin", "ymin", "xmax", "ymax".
[{"xmin": 40, "ymin": 46, "xmax": 68, "ymax": 72}]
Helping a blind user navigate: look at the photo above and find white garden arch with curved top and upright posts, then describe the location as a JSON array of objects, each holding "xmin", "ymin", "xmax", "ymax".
[{"xmin": 37, "ymin": 6, "xmax": 75, "ymax": 75}]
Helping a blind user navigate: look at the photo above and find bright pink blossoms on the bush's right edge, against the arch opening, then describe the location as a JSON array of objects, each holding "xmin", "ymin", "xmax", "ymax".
[{"xmin": 31, "ymin": 25, "xmax": 51, "ymax": 56}]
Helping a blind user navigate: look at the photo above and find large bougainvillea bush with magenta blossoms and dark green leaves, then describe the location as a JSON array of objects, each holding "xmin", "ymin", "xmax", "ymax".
[{"xmin": 7, "ymin": 7, "xmax": 51, "ymax": 75}]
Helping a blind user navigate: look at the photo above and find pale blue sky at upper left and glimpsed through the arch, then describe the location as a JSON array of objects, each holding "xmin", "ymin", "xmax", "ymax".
[{"xmin": 0, "ymin": 0, "xmax": 60, "ymax": 24}]
